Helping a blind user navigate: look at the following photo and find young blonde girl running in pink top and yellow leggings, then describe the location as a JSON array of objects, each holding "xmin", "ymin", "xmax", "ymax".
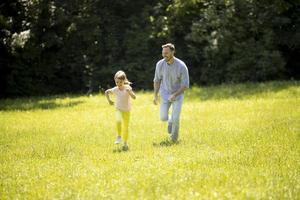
[{"xmin": 105, "ymin": 71, "xmax": 136, "ymax": 150}]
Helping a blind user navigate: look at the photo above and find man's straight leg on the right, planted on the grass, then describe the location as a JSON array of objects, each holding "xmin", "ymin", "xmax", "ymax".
[{"xmin": 171, "ymin": 96, "xmax": 183, "ymax": 142}]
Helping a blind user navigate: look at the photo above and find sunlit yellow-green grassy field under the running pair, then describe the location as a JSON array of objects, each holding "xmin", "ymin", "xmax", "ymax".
[{"xmin": 0, "ymin": 82, "xmax": 300, "ymax": 200}]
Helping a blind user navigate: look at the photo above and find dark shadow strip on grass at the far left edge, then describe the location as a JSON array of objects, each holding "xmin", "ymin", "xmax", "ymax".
[{"xmin": 0, "ymin": 96, "xmax": 84, "ymax": 111}]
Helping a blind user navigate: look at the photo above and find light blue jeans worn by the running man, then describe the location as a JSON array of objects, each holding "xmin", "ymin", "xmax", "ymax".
[{"xmin": 160, "ymin": 95, "xmax": 183, "ymax": 142}]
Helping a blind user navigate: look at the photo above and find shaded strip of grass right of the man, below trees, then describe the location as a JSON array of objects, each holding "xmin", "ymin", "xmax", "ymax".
[{"xmin": 186, "ymin": 81, "xmax": 300, "ymax": 101}]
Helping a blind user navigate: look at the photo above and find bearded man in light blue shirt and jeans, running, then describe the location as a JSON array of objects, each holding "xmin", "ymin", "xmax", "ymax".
[{"xmin": 153, "ymin": 43, "xmax": 189, "ymax": 142}]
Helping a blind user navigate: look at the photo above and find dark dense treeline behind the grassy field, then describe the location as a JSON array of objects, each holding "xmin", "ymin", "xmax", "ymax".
[{"xmin": 0, "ymin": 0, "xmax": 300, "ymax": 97}]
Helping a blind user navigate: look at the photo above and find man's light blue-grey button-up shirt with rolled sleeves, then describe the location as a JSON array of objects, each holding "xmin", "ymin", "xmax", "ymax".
[{"xmin": 153, "ymin": 57, "xmax": 190, "ymax": 101}]
